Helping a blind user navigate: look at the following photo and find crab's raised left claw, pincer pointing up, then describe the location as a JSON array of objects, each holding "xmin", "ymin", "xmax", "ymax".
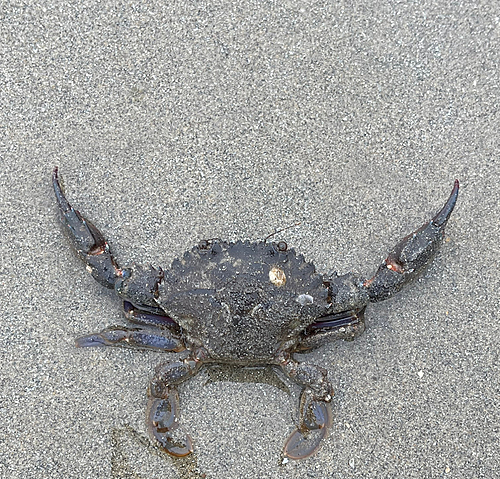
[{"xmin": 52, "ymin": 167, "xmax": 124, "ymax": 288}]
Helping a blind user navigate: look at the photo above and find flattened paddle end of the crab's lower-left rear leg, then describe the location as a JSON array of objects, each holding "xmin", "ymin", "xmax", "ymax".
[{"xmin": 147, "ymin": 388, "xmax": 193, "ymax": 457}]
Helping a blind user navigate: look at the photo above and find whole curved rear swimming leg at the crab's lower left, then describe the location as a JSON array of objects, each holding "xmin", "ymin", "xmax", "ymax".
[{"xmin": 146, "ymin": 357, "xmax": 201, "ymax": 457}]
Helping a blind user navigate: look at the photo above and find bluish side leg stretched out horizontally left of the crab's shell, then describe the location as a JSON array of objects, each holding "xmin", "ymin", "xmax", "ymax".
[{"xmin": 76, "ymin": 326, "xmax": 186, "ymax": 353}]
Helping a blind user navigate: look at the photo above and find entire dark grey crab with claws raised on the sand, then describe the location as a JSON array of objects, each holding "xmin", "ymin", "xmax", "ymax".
[{"xmin": 52, "ymin": 168, "xmax": 459, "ymax": 459}]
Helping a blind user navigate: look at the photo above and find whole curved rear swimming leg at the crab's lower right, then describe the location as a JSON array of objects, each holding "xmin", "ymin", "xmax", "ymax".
[{"xmin": 281, "ymin": 359, "xmax": 333, "ymax": 459}]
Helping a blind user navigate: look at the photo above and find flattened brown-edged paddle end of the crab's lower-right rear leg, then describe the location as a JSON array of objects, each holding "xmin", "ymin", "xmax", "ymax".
[{"xmin": 283, "ymin": 392, "xmax": 332, "ymax": 460}]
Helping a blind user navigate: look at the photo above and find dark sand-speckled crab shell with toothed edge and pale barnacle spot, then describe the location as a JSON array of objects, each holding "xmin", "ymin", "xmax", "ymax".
[{"xmin": 157, "ymin": 241, "xmax": 331, "ymax": 362}]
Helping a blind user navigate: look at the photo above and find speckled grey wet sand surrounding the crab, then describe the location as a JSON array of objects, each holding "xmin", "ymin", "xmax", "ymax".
[{"xmin": 0, "ymin": 1, "xmax": 500, "ymax": 479}]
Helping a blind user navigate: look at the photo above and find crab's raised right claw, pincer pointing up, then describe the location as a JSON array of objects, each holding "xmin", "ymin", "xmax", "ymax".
[{"xmin": 364, "ymin": 180, "xmax": 459, "ymax": 302}]
